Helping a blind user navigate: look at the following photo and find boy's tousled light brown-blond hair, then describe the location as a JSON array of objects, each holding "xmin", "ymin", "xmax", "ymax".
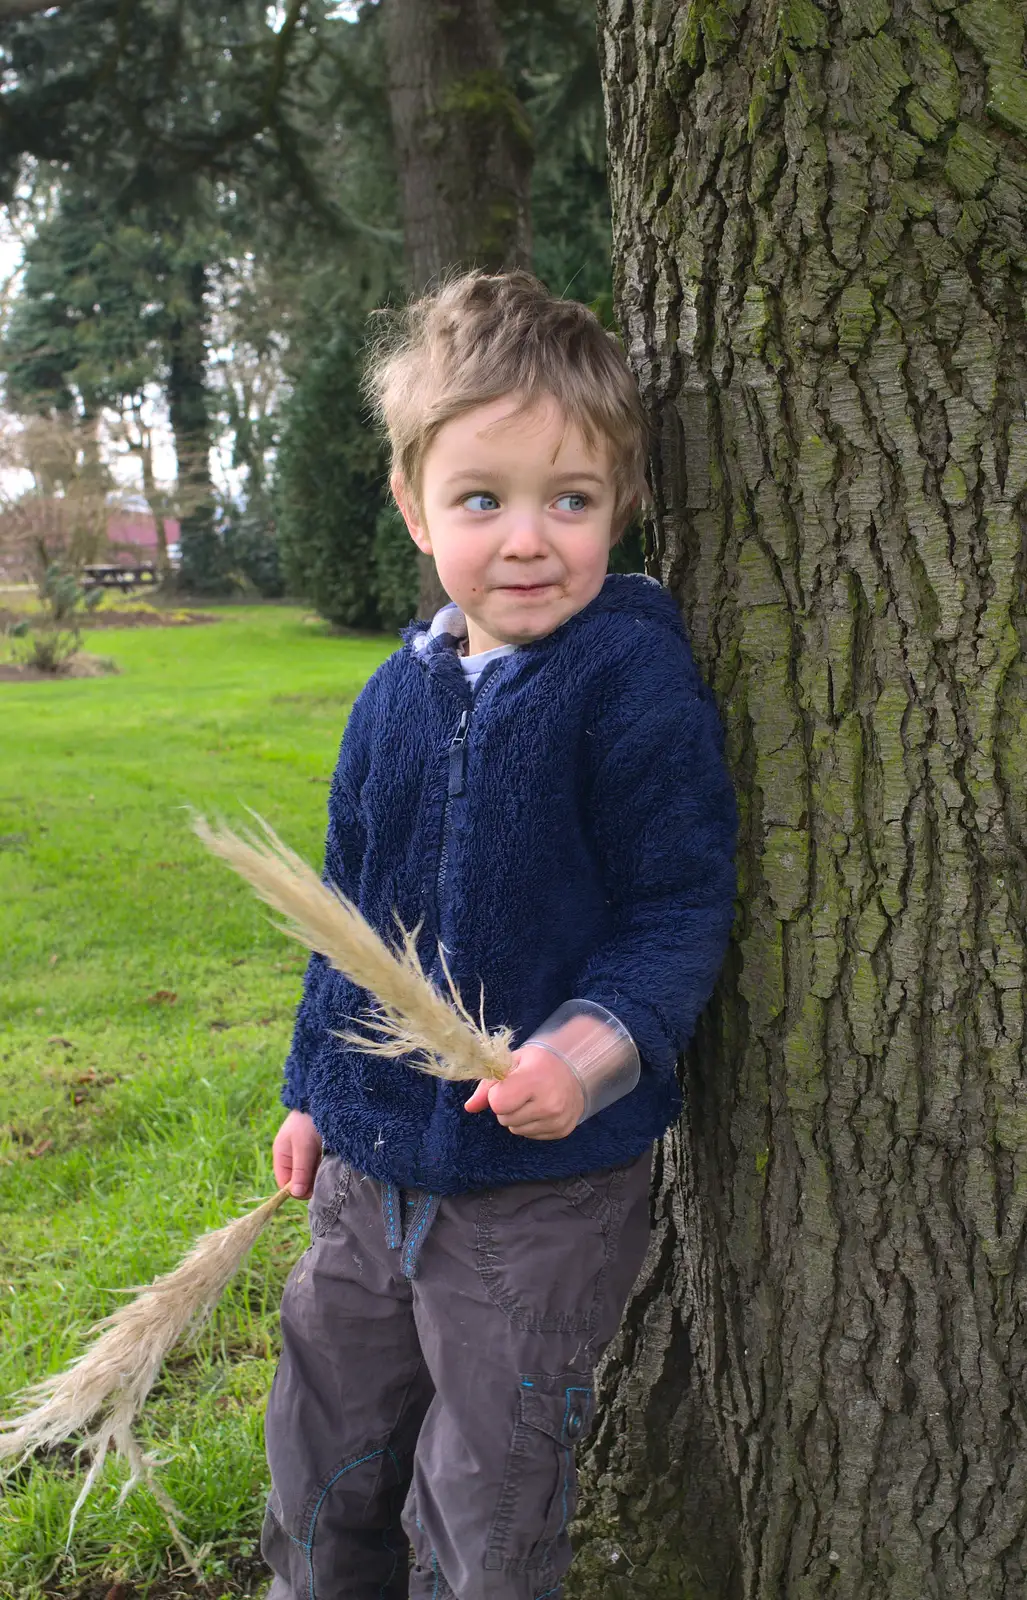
[{"xmin": 365, "ymin": 269, "xmax": 648, "ymax": 534}]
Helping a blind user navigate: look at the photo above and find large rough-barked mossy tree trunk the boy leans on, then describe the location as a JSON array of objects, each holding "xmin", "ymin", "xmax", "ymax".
[{"xmin": 571, "ymin": 0, "xmax": 1027, "ymax": 1600}]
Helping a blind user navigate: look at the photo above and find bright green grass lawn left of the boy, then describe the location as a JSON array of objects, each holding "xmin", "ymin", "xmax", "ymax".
[{"xmin": 0, "ymin": 606, "xmax": 397, "ymax": 1600}]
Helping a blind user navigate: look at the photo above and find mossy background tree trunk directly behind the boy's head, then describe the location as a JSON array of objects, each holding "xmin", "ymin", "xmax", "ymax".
[{"xmin": 386, "ymin": 0, "xmax": 533, "ymax": 616}]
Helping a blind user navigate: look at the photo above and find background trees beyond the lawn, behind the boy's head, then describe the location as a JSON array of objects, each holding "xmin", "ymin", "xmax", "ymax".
[{"xmin": 0, "ymin": 0, "xmax": 641, "ymax": 629}]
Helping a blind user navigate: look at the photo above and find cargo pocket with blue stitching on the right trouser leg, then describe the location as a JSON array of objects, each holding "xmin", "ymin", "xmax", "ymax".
[{"xmin": 485, "ymin": 1373, "xmax": 593, "ymax": 1571}]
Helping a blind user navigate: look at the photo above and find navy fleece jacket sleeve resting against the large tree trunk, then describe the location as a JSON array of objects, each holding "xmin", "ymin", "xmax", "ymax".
[{"xmin": 574, "ymin": 656, "xmax": 737, "ymax": 1072}]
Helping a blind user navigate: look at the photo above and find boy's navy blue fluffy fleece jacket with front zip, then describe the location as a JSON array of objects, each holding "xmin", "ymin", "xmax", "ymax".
[{"xmin": 283, "ymin": 574, "xmax": 736, "ymax": 1194}]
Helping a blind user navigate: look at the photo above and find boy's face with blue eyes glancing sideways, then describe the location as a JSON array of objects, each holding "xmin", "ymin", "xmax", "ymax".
[{"xmin": 392, "ymin": 395, "xmax": 616, "ymax": 654}]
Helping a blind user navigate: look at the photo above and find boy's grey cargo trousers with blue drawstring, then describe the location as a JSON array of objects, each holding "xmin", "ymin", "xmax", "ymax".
[{"xmin": 262, "ymin": 1150, "xmax": 651, "ymax": 1600}]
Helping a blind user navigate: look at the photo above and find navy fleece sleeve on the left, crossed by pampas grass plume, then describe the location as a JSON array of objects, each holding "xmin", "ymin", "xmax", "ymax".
[{"xmin": 282, "ymin": 675, "xmax": 371, "ymax": 1110}]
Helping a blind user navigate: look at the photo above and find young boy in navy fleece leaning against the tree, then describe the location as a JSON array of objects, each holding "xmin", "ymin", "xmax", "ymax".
[{"xmin": 264, "ymin": 272, "xmax": 734, "ymax": 1600}]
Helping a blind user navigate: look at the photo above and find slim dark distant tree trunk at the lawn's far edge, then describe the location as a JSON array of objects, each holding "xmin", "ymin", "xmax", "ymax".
[{"xmin": 166, "ymin": 261, "xmax": 222, "ymax": 590}]
